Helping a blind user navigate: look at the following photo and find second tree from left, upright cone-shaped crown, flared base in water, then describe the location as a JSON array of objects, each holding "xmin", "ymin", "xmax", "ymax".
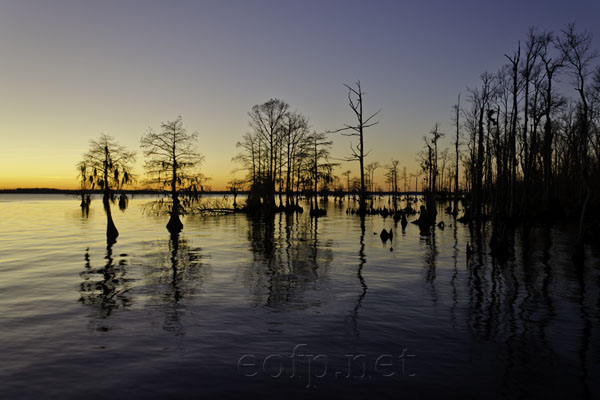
[{"xmin": 141, "ymin": 117, "xmax": 206, "ymax": 234}]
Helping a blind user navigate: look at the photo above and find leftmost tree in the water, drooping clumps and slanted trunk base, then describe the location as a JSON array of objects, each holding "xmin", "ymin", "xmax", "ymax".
[{"xmin": 79, "ymin": 134, "xmax": 135, "ymax": 243}]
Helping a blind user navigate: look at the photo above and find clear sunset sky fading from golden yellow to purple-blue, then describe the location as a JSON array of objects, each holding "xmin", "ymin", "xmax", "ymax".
[{"xmin": 0, "ymin": 0, "xmax": 600, "ymax": 190}]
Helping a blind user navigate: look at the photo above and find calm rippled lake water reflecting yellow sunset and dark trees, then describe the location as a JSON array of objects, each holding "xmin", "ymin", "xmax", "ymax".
[{"xmin": 0, "ymin": 195, "xmax": 600, "ymax": 399}]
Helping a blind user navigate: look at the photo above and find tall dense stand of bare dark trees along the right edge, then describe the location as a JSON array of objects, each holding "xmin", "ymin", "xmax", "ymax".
[{"xmin": 456, "ymin": 24, "xmax": 600, "ymax": 260}]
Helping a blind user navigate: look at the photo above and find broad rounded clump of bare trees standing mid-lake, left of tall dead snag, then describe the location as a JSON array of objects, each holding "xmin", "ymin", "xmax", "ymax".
[{"xmin": 233, "ymin": 99, "xmax": 333, "ymax": 214}]
